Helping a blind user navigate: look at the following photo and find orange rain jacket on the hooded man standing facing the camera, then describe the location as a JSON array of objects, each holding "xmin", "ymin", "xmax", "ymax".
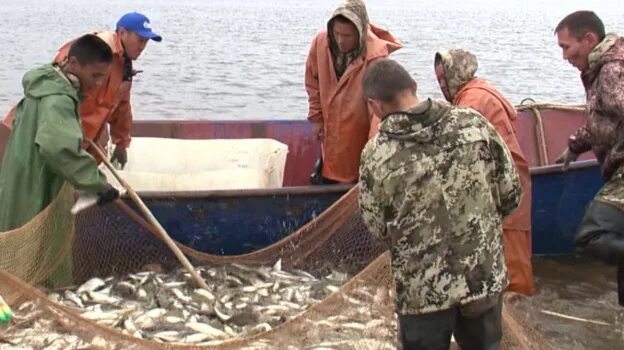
[{"xmin": 305, "ymin": 3, "xmax": 402, "ymax": 183}]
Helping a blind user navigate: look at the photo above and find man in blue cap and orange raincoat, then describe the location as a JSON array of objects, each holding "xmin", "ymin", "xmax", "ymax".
[{"xmin": 4, "ymin": 12, "xmax": 162, "ymax": 167}]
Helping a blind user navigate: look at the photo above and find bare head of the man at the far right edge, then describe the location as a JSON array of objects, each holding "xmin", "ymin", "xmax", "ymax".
[{"xmin": 555, "ymin": 11, "xmax": 605, "ymax": 72}]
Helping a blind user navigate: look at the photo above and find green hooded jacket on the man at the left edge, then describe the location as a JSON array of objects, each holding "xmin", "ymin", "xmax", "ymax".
[{"xmin": 0, "ymin": 64, "xmax": 106, "ymax": 232}]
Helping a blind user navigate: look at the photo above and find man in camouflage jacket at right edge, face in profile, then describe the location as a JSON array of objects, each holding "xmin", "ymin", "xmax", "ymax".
[{"xmin": 555, "ymin": 11, "xmax": 624, "ymax": 306}]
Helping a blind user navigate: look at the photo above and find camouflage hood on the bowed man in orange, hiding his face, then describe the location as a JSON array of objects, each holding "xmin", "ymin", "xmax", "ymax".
[{"xmin": 435, "ymin": 49, "xmax": 479, "ymax": 101}]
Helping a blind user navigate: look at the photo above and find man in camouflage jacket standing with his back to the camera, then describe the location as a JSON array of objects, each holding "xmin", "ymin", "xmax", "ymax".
[{"xmin": 359, "ymin": 59, "xmax": 521, "ymax": 349}]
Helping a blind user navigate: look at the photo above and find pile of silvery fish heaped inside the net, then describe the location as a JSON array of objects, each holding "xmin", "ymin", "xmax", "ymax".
[{"xmin": 2, "ymin": 261, "xmax": 358, "ymax": 345}]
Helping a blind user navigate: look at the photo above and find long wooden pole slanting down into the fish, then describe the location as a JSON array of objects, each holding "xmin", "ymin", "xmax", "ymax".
[{"xmin": 89, "ymin": 140, "xmax": 209, "ymax": 290}]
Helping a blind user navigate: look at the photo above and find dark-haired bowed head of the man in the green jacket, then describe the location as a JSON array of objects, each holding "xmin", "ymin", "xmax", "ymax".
[{"xmin": 64, "ymin": 34, "xmax": 113, "ymax": 93}]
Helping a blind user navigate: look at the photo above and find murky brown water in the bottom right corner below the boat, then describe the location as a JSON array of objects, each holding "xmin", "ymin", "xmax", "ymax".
[{"xmin": 514, "ymin": 256, "xmax": 624, "ymax": 350}]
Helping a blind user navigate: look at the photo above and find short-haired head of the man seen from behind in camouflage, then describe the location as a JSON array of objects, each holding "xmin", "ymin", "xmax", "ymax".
[{"xmin": 362, "ymin": 58, "xmax": 418, "ymax": 117}]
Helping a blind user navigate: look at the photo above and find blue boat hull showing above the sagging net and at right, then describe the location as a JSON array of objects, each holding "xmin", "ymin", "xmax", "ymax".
[{"xmin": 89, "ymin": 161, "xmax": 603, "ymax": 255}]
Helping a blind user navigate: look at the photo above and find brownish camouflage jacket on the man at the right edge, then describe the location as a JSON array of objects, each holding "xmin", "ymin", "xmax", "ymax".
[{"xmin": 568, "ymin": 34, "xmax": 624, "ymax": 181}]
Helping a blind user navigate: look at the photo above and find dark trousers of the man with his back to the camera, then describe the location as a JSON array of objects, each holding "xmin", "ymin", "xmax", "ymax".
[{"xmin": 399, "ymin": 298, "xmax": 503, "ymax": 350}]
